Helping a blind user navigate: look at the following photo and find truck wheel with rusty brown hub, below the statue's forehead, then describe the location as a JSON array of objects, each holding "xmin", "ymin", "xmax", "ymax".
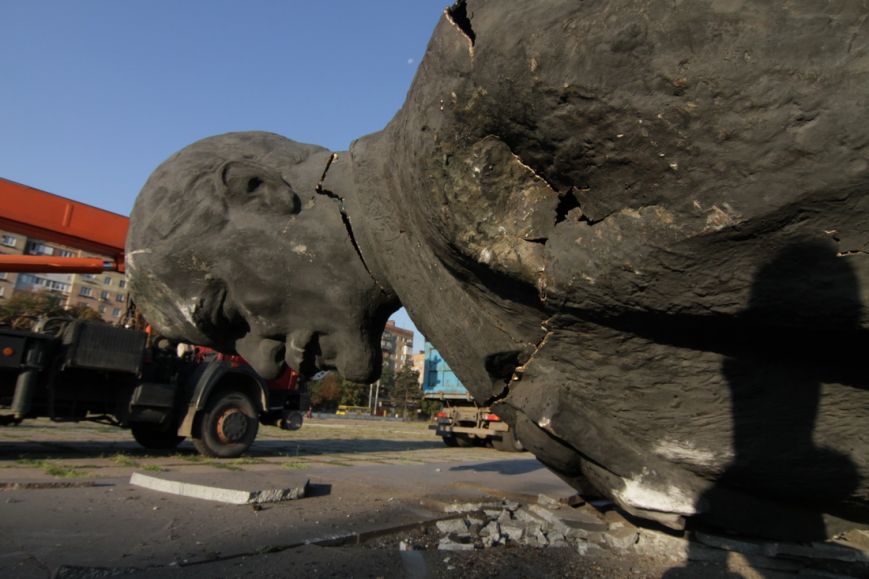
[{"xmin": 193, "ymin": 390, "xmax": 259, "ymax": 458}]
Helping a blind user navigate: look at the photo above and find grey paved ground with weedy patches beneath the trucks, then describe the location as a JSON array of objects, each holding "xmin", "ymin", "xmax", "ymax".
[{"xmin": 0, "ymin": 418, "xmax": 632, "ymax": 577}]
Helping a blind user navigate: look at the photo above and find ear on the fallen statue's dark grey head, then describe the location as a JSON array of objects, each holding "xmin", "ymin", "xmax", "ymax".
[{"xmin": 220, "ymin": 161, "xmax": 302, "ymax": 214}]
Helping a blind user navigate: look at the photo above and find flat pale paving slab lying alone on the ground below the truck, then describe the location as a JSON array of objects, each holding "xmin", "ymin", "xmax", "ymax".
[{"xmin": 130, "ymin": 471, "xmax": 310, "ymax": 505}]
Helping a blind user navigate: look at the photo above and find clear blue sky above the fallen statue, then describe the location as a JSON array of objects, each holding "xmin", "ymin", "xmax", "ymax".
[{"xmin": 0, "ymin": 0, "xmax": 450, "ymax": 352}]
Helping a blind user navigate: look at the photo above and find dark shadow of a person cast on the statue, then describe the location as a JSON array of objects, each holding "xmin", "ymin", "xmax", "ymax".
[{"xmin": 667, "ymin": 242, "xmax": 866, "ymax": 577}]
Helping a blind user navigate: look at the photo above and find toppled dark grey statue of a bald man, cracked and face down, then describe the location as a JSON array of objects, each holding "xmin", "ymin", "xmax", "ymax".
[{"xmin": 127, "ymin": 0, "xmax": 869, "ymax": 539}]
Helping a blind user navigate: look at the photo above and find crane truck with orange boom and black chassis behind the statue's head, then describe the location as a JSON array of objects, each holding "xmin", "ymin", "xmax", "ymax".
[{"xmin": 0, "ymin": 179, "xmax": 309, "ymax": 458}]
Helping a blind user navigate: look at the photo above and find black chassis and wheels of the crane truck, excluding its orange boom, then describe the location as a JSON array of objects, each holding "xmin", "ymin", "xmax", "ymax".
[{"xmin": 0, "ymin": 318, "xmax": 308, "ymax": 458}]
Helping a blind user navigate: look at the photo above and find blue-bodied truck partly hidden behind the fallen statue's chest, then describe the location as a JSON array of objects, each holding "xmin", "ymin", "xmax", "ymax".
[{"xmin": 422, "ymin": 341, "xmax": 524, "ymax": 452}]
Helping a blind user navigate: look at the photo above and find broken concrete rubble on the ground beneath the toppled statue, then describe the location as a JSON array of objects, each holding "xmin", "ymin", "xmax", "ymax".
[{"xmin": 418, "ymin": 495, "xmax": 869, "ymax": 577}]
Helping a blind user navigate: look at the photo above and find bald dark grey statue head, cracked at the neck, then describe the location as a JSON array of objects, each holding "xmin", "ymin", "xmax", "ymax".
[{"xmin": 126, "ymin": 132, "xmax": 396, "ymax": 382}]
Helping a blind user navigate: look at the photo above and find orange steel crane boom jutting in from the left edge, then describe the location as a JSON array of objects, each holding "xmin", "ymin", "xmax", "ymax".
[{"xmin": 0, "ymin": 178, "xmax": 130, "ymax": 273}]
